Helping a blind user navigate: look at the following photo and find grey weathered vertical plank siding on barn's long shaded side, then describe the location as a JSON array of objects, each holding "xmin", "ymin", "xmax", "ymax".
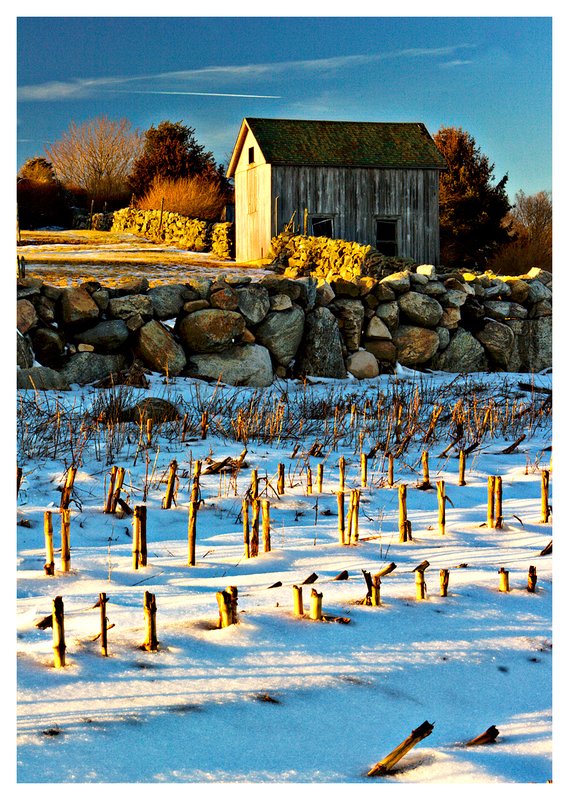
[{"xmin": 270, "ymin": 165, "xmax": 440, "ymax": 265}]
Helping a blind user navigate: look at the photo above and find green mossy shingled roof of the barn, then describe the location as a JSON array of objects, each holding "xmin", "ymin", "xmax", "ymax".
[{"xmin": 245, "ymin": 117, "xmax": 446, "ymax": 169}]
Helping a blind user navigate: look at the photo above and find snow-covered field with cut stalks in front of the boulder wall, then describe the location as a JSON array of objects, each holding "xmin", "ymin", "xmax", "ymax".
[{"xmin": 17, "ymin": 370, "xmax": 553, "ymax": 780}]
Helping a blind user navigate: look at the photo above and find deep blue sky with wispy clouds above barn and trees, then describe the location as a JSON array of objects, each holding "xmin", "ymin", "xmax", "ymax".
[{"xmin": 17, "ymin": 10, "xmax": 552, "ymax": 198}]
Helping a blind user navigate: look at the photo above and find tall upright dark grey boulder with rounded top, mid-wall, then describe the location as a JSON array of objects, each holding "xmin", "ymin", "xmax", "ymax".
[{"xmin": 296, "ymin": 306, "xmax": 346, "ymax": 378}]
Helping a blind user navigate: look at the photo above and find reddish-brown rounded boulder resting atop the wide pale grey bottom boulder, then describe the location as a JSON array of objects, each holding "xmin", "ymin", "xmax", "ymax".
[{"xmin": 177, "ymin": 310, "xmax": 244, "ymax": 353}]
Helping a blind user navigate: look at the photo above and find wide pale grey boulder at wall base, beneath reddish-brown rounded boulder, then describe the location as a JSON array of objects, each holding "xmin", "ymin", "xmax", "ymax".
[{"xmin": 186, "ymin": 344, "xmax": 273, "ymax": 386}]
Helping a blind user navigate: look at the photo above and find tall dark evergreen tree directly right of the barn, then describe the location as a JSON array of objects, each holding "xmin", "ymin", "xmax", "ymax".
[{"xmin": 434, "ymin": 127, "xmax": 511, "ymax": 269}]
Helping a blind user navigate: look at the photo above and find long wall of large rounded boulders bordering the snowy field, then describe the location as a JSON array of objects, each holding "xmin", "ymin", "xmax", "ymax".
[{"xmin": 18, "ymin": 265, "xmax": 552, "ymax": 388}]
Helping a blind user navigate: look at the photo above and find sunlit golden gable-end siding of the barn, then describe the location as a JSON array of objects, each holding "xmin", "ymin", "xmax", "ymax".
[{"xmin": 235, "ymin": 131, "xmax": 271, "ymax": 261}]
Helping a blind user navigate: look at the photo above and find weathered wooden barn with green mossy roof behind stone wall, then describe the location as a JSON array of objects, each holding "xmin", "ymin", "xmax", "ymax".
[{"xmin": 227, "ymin": 117, "xmax": 446, "ymax": 265}]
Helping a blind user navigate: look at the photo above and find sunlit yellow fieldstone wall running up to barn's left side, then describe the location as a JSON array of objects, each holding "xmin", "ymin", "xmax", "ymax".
[{"xmin": 110, "ymin": 208, "xmax": 234, "ymax": 259}]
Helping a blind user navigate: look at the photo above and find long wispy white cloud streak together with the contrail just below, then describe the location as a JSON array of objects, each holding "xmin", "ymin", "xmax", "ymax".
[{"xmin": 18, "ymin": 44, "xmax": 471, "ymax": 102}]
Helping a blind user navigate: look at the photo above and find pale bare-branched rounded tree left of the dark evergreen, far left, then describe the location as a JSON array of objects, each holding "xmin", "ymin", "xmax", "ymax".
[{"xmin": 46, "ymin": 115, "xmax": 143, "ymax": 209}]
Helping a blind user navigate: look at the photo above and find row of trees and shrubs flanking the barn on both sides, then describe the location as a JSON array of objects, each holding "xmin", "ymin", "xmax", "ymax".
[{"xmin": 18, "ymin": 116, "xmax": 552, "ymax": 274}]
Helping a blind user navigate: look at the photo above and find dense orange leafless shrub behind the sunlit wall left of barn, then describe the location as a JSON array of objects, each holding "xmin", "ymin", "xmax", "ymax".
[{"xmin": 137, "ymin": 176, "xmax": 227, "ymax": 221}]
